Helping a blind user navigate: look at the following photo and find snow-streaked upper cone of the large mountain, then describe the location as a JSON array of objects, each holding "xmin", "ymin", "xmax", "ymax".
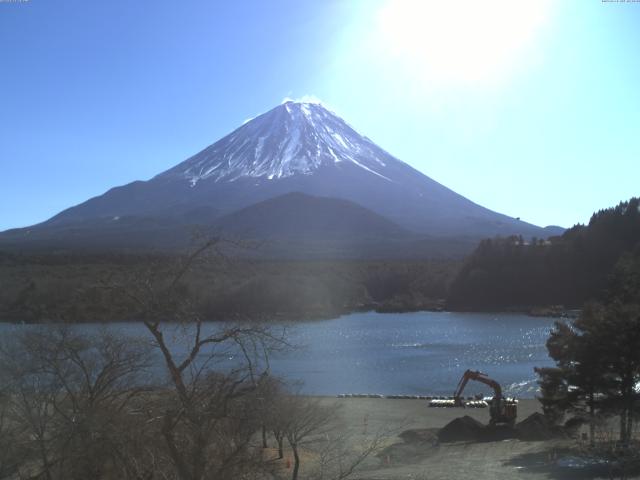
[{"xmin": 158, "ymin": 101, "xmax": 400, "ymax": 186}]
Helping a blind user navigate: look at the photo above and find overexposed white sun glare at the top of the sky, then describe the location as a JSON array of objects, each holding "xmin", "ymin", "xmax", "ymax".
[{"xmin": 378, "ymin": 0, "xmax": 549, "ymax": 83}]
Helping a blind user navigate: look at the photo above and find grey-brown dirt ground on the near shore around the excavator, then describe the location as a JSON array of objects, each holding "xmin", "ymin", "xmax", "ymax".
[{"xmin": 302, "ymin": 398, "xmax": 594, "ymax": 480}]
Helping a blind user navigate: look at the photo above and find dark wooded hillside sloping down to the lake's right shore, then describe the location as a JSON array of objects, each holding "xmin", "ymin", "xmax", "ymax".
[{"xmin": 447, "ymin": 198, "xmax": 640, "ymax": 310}]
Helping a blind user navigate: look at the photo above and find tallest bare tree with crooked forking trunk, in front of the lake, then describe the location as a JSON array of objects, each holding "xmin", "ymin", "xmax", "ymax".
[{"xmin": 105, "ymin": 238, "xmax": 284, "ymax": 480}]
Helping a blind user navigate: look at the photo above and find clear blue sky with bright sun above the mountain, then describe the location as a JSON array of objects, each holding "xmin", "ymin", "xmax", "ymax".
[{"xmin": 0, "ymin": 0, "xmax": 640, "ymax": 230}]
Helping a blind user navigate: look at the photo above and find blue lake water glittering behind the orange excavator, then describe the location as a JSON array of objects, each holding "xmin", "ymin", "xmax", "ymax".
[{"xmin": 0, "ymin": 312, "xmax": 554, "ymax": 398}]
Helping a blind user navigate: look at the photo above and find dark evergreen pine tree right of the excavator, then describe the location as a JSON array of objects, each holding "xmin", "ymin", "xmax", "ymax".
[{"xmin": 536, "ymin": 249, "xmax": 640, "ymax": 445}]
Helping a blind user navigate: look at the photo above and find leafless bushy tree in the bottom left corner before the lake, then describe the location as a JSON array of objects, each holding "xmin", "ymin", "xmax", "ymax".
[{"xmin": 0, "ymin": 328, "xmax": 147, "ymax": 479}]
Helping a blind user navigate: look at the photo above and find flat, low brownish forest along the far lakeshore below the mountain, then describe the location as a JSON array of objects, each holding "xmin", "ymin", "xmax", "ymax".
[{"xmin": 0, "ymin": 249, "xmax": 460, "ymax": 323}]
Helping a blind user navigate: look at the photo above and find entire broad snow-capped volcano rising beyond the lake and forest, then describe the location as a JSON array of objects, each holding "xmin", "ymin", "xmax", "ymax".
[{"xmin": 0, "ymin": 101, "xmax": 561, "ymax": 255}]
